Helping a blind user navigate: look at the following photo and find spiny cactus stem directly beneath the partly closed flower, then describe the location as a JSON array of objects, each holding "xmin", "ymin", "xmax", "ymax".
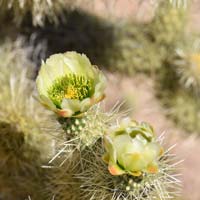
[{"xmin": 79, "ymin": 146, "xmax": 180, "ymax": 200}]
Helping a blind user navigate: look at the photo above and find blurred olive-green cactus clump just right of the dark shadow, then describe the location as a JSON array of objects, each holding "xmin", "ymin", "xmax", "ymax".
[{"xmin": 106, "ymin": 22, "xmax": 162, "ymax": 74}]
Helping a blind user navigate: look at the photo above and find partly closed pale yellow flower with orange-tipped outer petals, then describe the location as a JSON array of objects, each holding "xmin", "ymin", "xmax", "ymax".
[{"xmin": 104, "ymin": 120, "xmax": 163, "ymax": 176}]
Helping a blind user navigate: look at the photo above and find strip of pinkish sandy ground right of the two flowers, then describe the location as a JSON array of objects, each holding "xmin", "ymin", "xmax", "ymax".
[{"xmin": 106, "ymin": 73, "xmax": 200, "ymax": 200}]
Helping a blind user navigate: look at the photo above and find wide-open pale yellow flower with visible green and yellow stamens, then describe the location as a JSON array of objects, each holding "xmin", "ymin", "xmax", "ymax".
[{"xmin": 36, "ymin": 52, "xmax": 106, "ymax": 117}]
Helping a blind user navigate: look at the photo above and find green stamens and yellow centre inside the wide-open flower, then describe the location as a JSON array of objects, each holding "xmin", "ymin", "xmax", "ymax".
[{"xmin": 48, "ymin": 74, "xmax": 94, "ymax": 108}]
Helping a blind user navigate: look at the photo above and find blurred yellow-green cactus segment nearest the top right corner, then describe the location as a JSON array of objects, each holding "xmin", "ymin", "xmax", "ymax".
[{"xmin": 149, "ymin": 1, "xmax": 187, "ymax": 47}]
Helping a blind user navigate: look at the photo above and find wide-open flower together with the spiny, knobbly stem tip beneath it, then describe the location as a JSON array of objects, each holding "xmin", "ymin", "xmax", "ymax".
[{"xmin": 36, "ymin": 52, "xmax": 110, "ymax": 152}]
